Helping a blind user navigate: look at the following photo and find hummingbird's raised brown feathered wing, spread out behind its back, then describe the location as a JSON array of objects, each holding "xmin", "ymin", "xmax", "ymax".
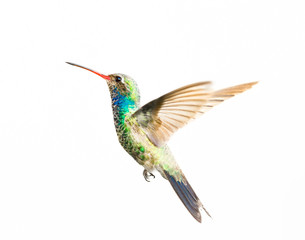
[{"xmin": 133, "ymin": 82, "xmax": 257, "ymax": 147}]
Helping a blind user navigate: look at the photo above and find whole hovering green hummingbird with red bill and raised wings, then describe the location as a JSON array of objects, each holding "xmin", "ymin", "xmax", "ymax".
[{"xmin": 66, "ymin": 62, "xmax": 257, "ymax": 222}]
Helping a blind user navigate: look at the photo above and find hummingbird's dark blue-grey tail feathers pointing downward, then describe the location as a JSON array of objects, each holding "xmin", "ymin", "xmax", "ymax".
[{"xmin": 164, "ymin": 170, "xmax": 211, "ymax": 223}]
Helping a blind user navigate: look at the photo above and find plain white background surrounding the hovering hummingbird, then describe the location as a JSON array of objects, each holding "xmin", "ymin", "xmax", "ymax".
[{"xmin": 0, "ymin": 0, "xmax": 305, "ymax": 240}]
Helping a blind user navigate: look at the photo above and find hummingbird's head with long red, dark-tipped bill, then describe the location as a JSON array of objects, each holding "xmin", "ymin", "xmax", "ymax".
[{"xmin": 67, "ymin": 62, "xmax": 140, "ymax": 105}]
